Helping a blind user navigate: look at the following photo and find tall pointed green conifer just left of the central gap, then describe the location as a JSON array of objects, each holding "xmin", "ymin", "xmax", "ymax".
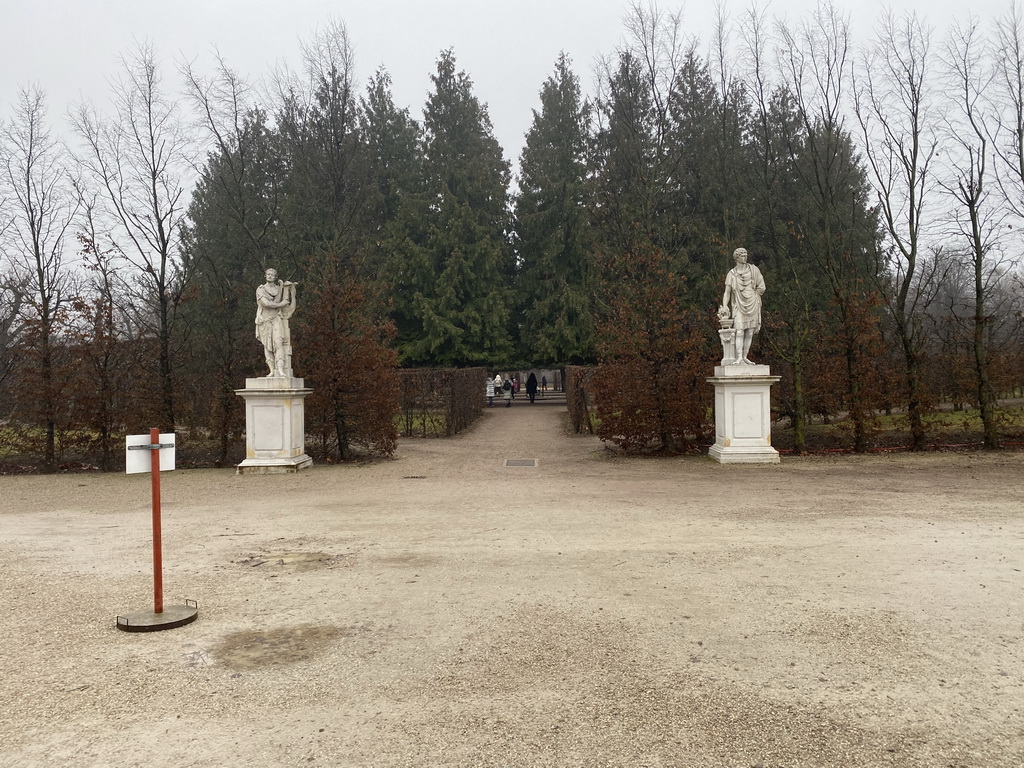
[{"xmin": 388, "ymin": 51, "xmax": 513, "ymax": 366}]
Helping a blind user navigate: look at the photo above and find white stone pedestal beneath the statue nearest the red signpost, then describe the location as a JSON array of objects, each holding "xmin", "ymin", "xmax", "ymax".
[{"xmin": 234, "ymin": 376, "xmax": 313, "ymax": 474}]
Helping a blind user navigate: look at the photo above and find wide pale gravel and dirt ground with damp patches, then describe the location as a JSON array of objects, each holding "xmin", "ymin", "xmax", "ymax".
[{"xmin": 0, "ymin": 397, "xmax": 1024, "ymax": 768}]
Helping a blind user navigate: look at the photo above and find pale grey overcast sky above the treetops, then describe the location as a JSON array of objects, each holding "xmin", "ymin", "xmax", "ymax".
[{"xmin": 0, "ymin": 0, "xmax": 1010, "ymax": 170}]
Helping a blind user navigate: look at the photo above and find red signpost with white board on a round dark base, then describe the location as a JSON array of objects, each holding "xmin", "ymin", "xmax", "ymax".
[{"xmin": 117, "ymin": 429, "xmax": 199, "ymax": 632}]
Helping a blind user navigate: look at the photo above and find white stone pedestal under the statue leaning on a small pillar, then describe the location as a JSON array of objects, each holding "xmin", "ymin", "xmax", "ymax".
[{"xmin": 708, "ymin": 366, "xmax": 781, "ymax": 464}]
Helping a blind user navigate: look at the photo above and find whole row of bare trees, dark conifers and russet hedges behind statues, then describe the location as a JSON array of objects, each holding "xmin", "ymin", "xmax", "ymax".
[{"xmin": 0, "ymin": 6, "xmax": 1024, "ymax": 469}]
